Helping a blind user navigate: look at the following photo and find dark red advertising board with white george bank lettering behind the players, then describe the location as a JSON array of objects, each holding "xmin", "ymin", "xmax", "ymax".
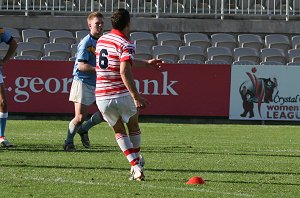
[{"xmin": 3, "ymin": 60, "xmax": 230, "ymax": 116}]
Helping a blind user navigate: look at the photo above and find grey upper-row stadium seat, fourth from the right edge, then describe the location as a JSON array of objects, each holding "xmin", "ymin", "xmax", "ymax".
[{"xmin": 211, "ymin": 33, "xmax": 237, "ymax": 51}]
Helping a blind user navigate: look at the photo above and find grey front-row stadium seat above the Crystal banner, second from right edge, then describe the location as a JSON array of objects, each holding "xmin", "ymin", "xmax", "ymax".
[{"xmin": 261, "ymin": 48, "xmax": 287, "ymax": 64}]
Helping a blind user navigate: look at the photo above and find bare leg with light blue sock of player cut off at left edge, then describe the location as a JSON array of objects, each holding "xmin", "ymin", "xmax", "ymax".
[{"xmin": 0, "ymin": 82, "xmax": 13, "ymax": 147}]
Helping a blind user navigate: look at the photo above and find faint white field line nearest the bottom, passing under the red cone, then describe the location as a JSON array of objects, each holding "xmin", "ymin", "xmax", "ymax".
[{"xmin": 23, "ymin": 177, "xmax": 253, "ymax": 197}]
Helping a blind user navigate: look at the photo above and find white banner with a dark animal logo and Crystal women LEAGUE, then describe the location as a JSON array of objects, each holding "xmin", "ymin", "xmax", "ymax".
[{"xmin": 229, "ymin": 65, "xmax": 300, "ymax": 121}]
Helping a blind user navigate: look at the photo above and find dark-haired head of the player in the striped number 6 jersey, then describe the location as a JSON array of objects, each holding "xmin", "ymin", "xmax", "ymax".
[{"xmin": 111, "ymin": 8, "xmax": 130, "ymax": 31}]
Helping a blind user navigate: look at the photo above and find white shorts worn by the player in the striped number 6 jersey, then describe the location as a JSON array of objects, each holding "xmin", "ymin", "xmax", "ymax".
[{"xmin": 96, "ymin": 95, "xmax": 137, "ymax": 126}]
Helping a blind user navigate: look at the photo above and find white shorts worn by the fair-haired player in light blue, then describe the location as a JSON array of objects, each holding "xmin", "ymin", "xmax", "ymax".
[{"xmin": 69, "ymin": 79, "xmax": 96, "ymax": 106}]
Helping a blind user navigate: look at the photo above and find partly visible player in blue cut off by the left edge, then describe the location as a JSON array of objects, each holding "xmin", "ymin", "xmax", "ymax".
[{"xmin": 0, "ymin": 28, "xmax": 18, "ymax": 147}]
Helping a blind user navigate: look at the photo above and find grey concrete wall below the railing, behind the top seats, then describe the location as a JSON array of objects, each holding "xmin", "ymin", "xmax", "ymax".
[{"xmin": 0, "ymin": 15, "xmax": 300, "ymax": 35}]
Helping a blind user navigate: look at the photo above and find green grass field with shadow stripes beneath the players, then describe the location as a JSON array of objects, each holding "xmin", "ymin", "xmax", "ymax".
[{"xmin": 0, "ymin": 120, "xmax": 300, "ymax": 198}]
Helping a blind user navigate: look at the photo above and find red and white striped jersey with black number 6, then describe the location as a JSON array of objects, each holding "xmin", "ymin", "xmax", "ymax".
[{"xmin": 95, "ymin": 29, "xmax": 135, "ymax": 100}]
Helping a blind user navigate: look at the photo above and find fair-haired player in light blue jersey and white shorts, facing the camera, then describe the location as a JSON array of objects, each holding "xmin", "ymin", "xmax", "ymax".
[{"xmin": 63, "ymin": 12, "xmax": 104, "ymax": 152}]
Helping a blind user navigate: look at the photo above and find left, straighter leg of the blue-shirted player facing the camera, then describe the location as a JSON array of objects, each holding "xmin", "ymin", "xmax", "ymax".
[{"xmin": 64, "ymin": 102, "xmax": 88, "ymax": 151}]
